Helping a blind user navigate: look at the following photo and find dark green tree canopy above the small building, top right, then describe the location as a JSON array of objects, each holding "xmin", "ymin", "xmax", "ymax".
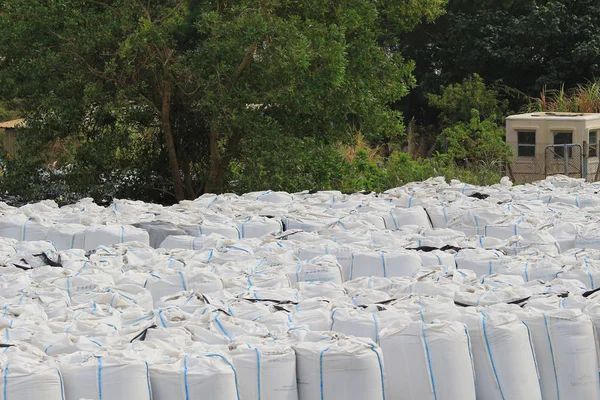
[{"xmin": 402, "ymin": 0, "xmax": 600, "ymax": 122}]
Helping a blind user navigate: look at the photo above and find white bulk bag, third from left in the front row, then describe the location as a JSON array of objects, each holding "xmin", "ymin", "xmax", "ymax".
[{"xmin": 150, "ymin": 354, "xmax": 239, "ymax": 400}]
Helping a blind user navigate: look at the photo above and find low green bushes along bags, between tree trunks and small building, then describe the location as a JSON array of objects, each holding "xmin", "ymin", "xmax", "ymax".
[{"xmin": 229, "ymin": 137, "xmax": 503, "ymax": 193}]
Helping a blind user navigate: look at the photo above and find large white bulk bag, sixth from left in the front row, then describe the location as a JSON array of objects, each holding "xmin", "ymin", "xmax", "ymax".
[{"xmin": 379, "ymin": 321, "xmax": 475, "ymax": 400}]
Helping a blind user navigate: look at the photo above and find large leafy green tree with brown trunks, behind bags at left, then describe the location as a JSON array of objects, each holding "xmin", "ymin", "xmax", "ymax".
[{"xmin": 0, "ymin": 0, "xmax": 445, "ymax": 200}]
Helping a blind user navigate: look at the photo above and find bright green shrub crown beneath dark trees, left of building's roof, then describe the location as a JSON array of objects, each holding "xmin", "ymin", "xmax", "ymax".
[{"xmin": 428, "ymin": 74, "xmax": 508, "ymax": 126}]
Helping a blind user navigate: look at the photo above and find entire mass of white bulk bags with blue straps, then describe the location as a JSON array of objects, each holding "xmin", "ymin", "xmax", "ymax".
[{"xmin": 0, "ymin": 177, "xmax": 600, "ymax": 400}]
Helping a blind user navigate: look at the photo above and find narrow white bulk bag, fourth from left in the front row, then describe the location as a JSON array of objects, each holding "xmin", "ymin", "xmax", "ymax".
[{"xmin": 229, "ymin": 344, "xmax": 298, "ymax": 400}]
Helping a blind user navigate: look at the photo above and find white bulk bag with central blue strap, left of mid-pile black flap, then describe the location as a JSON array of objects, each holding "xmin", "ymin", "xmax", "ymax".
[{"xmin": 350, "ymin": 250, "xmax": 423, "ymax": 280}]
